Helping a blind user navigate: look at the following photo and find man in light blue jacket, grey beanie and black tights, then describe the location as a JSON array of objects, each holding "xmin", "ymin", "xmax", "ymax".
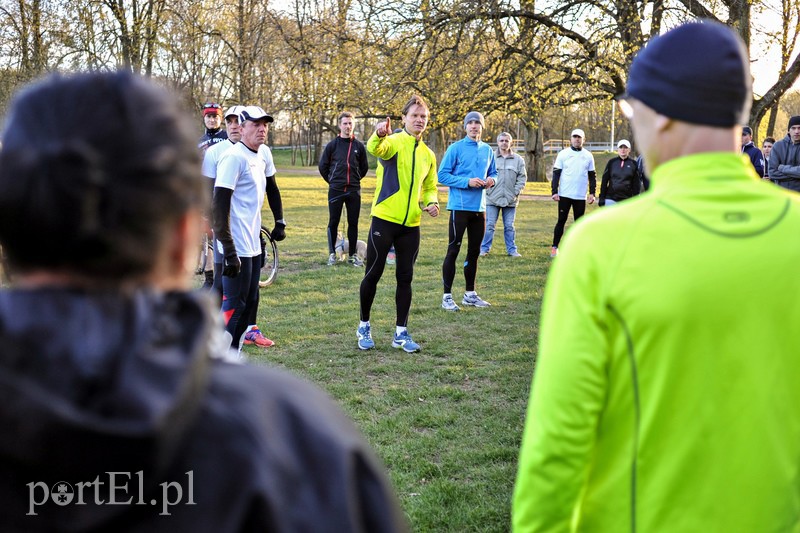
[{"xmin": 439, "ymin": 111, "xmax": 497, "ymax": 311}]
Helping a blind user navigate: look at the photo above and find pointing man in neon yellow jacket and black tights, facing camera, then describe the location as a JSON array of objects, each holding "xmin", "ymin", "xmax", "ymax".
[{"xmin": 356, "ymin": 95, "xmax": 439, "ymax": 353}]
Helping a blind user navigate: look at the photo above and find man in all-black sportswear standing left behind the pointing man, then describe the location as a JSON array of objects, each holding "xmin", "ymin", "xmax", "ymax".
[{"xmin": 319, "ymin": 111, "xmax": 369, "ymax": 266}]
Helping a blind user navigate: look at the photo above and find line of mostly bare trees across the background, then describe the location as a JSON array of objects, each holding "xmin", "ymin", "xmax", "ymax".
[{"xmin": 0, "ymin": 0, "xmax": 800, "ymax": 180}]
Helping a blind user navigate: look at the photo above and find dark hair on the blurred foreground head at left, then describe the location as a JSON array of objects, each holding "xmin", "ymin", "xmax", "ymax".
[{"xmin": 0, "ymin": 72, "xmax": 206, "ymax": 281}]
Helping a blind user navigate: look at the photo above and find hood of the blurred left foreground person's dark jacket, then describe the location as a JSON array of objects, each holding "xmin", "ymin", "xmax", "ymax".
[{"xmin": 0, "ymin": 289, "xmax": 224, "ymax": 481}]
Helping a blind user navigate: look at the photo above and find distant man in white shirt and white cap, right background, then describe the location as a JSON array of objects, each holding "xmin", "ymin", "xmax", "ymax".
[{"xmin": 550, "ymin": 129, "xmax": 597, "ymax": 257}]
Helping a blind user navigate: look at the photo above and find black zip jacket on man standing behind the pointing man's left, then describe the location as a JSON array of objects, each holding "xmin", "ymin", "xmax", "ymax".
[{"xmin": 319, "ymin": 135, "xmax": 369, "ymax": 192}]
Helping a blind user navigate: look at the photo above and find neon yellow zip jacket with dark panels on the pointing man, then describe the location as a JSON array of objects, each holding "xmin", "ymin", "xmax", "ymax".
[{"xmin": 367, "ymin": 130, "xmax": 439, "ymax": 227}]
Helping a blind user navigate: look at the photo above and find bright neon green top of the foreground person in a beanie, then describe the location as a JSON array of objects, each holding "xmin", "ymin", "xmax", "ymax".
[{"xmin": 513, "ymin": 153, "xmax": 800, "ymax": 533}]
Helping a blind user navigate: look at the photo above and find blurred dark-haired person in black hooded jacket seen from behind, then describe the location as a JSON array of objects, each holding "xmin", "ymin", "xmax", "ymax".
[{"xmin": 0, "ymin": 73, "xmax": 405, "ymax": 533}]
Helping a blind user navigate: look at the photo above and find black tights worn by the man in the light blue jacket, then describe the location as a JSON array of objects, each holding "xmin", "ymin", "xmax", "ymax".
[{"xmin": 442, "ymin": 211, "xmax": 486, "ymax": 293}]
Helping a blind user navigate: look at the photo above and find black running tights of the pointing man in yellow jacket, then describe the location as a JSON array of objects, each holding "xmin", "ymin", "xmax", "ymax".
[{"xmin": 360, "ymin": 217, "xmax": 419, "ymax": 327}]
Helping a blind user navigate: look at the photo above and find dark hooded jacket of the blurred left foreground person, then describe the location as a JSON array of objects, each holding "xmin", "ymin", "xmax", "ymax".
[{"xmin": 0, "ymin": 289, "xmax": 405, "ymax": 533}]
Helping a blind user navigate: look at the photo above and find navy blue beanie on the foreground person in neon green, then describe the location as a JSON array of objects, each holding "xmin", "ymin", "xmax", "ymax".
[{"xmin": 627, "ymin": 21, "xmax": 752, "ymax": 127}]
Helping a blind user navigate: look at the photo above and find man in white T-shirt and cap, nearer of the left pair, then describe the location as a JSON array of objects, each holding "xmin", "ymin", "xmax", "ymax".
[{"xmin": 212, "ymin": 106, "xmax": 286, "ymax": 350}]
